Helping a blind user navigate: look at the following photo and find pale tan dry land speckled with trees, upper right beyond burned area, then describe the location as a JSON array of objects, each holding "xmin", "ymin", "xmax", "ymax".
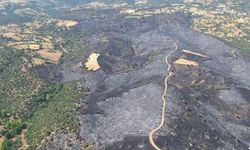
[{"xmin": 190, "ymin": 5, "xmax": 250, "ymax": 41}]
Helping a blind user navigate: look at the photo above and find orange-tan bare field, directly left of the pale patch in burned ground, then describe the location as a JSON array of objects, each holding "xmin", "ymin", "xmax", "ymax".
[{"xmin": 36, "ymin": 50, "xmax": 62, "ymax": 62}]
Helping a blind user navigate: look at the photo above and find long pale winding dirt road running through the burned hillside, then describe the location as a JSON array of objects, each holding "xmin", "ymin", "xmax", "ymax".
[{"xmin": 149, "ymin": 43, "xmax": 178, "ymax": 150}]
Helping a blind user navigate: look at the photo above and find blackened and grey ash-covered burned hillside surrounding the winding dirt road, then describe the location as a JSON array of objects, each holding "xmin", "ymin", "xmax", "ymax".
[{"xmin": 38, "ymin": 7, "xmax": 250, "ymax": 150}]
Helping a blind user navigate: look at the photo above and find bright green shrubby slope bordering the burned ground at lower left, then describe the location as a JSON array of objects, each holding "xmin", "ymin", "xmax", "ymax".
[{"xmin": 27, "ymin": 81, "xmax": 81, "ymax": 149}]
